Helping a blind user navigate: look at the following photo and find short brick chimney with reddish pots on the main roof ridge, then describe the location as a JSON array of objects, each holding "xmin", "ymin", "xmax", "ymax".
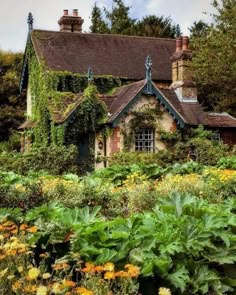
[{"xmin": 58, "ymin": 9, "xmax": 84, "ymax": 33}]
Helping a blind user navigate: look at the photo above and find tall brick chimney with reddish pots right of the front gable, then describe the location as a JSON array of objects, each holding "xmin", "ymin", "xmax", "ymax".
[{"xmin": 170, "ymin": 36, "xmax": 197, "ymax": 102}]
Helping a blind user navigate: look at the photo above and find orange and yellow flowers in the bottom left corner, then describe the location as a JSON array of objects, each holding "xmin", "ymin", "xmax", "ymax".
[{"xmin": 0, "ymin": 219, "xmax": 139, "ymax": 295}]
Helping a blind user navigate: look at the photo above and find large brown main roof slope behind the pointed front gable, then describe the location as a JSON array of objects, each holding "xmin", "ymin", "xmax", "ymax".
[{"xmin": 31, "ymin": 30, "xmax": 175, "ymax": 81}]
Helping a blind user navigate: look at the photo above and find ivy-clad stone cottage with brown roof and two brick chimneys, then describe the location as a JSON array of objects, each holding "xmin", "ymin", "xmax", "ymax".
[{"xmin": 19, "ymin": 10, "xmax": 236, "ymax": 166}]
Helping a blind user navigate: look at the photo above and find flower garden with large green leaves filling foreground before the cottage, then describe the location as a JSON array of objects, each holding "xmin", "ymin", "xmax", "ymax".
[{"xmin": 0, "ymin": 154, "xmax": 236, "ymax": 295}]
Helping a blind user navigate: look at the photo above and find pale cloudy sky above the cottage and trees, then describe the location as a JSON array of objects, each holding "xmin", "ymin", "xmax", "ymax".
[{"xmin": 0, "ymin": 0, "xmax": 216, "ymax": 51}]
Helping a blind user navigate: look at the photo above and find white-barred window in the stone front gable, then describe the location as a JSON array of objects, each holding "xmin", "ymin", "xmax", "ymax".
[{"xmin": 135, "ymin": 129, "xmax": 154, "ymax": 153}]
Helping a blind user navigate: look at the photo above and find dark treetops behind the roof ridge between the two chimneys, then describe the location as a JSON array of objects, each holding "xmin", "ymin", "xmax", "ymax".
[{"xmin": 90, "ymin": 0, "xmax": 181, "ymax": 38}]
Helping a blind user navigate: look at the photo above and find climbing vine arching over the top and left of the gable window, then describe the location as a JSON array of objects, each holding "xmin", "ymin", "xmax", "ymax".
[{"xmin": 121, "ymin": 105, "xmax": 163, "ymax": 151}]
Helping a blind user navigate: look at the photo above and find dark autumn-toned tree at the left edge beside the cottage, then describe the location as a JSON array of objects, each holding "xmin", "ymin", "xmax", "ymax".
[{"xmin": 0, "ymin": 50, "xmax": 26, "ymax": 141}]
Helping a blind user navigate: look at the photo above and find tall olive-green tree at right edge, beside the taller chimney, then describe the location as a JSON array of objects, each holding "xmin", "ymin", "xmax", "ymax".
[{"xmin": 192, "ymin": 0, "xmax": 236, "ymax": 115}]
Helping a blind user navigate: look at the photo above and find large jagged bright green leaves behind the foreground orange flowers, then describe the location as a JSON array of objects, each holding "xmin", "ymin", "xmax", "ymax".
[{"xmin": 1, "ymin": 194, "xmax": 236, "ymax": 294}]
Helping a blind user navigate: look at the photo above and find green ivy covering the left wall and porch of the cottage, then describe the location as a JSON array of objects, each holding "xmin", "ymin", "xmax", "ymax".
[{"xmin": 28, "ymin": 46, "xmax": 114, "ymax": 150}]
